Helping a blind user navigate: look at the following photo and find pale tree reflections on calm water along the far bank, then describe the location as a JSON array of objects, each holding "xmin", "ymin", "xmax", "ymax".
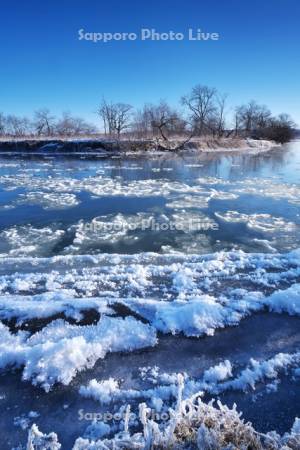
[{"xmin": 18, "ymin": 142, "xmax": 299, "ymax": 182}]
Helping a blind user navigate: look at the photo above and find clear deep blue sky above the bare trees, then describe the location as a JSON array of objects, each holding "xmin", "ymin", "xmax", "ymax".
[{"xmin": 0, "ymin": 0, "xmax": 300, "ymax": 125}]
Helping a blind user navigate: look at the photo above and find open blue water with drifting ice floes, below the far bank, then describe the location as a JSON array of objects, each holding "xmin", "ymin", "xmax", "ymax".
[{"xmin": 0, "ymin": 141, "xmax": 300, "ymax": 256}]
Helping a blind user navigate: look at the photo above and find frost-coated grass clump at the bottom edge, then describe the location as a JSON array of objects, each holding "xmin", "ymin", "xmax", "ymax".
[{"xmin": 29, "ymin": 374, "xmax": 300, "ymax": 450}]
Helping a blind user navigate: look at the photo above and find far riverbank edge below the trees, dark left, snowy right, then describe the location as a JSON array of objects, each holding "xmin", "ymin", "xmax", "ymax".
[{"xmin": 0, "ymin": 137, "xmax": 278, "ymax": 155}]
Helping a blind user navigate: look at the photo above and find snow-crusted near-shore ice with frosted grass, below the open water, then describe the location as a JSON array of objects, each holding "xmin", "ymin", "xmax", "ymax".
[{"xmin": 0, "ymin": 251, "xmax": 300, "ymax": 450}]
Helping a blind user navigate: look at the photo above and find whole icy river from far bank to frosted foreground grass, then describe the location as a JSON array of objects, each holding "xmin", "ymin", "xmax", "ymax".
[{"xmin": 0, "ymin": 141, "xmax": 300, "ymax": 449}]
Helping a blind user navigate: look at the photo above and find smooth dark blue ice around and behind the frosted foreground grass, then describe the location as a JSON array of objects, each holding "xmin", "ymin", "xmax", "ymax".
[{"xmin": 0, "ymin": 313, "xmax": 299, "ymax": 449}]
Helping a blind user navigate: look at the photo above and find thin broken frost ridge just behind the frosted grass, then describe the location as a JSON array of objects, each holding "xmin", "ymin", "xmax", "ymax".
[{"xmin": 79, "ymin": 352, "xmax": 300, "ymax": 412}]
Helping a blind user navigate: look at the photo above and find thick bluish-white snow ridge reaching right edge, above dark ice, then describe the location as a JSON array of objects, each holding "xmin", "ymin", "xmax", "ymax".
[{"xmin": 124, "ymin": 285, "xmax": 300, "ymax": 337}]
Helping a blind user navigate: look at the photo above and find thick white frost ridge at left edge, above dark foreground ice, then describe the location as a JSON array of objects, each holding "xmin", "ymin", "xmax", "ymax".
[{"xmin": 0, "ymin": 316, "xmax": 157, "ymax": 391}]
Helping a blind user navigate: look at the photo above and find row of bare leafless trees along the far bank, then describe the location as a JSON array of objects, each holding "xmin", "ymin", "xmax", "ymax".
[{"xmin": 0, "ymin": 85, "xmax": 295, "ymax": 142}]
